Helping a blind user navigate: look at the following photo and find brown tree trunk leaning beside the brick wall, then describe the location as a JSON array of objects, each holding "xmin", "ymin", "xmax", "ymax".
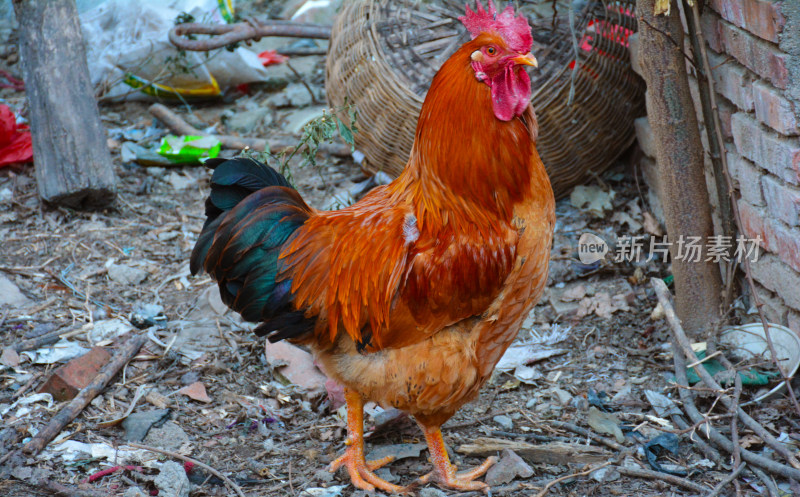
[{"xmin": 636, "ymin": 0, "xmax": 722, "ymax": 334}]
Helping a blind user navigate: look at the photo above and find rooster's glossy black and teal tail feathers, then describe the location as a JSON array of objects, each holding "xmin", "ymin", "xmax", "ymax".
[{"xmin": 190, "ymin": 158, "xmax": 315, "ymax": 341}]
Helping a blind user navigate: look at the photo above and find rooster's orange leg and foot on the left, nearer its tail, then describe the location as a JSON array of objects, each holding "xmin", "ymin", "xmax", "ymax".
[{"xmin": 328, "ymin": 389, "xmax": 403, "ymax": 492}]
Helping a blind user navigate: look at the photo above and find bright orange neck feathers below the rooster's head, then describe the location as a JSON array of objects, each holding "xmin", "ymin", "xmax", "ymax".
[{"xmin": 396, "ymin": 35, "xmax": 541, "ymax": 229}]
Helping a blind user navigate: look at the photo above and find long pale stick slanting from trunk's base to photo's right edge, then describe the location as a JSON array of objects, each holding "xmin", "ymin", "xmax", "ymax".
[{"xmin": 650, "ymin": 278, "xmax": 800, "ymax": 469}]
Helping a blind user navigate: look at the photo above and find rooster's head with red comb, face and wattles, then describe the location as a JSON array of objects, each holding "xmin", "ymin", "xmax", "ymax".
[{"xmin": 459, "ymin": 0, "xmax": 537, "ymax": 121}]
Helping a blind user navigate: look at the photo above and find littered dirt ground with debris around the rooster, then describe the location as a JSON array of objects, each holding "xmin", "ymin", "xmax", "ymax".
[{"xmin": 0, "ymin": 3, "xmax": 800, "ymax": 497}]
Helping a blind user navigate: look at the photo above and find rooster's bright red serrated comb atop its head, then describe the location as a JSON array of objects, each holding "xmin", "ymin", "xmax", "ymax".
[{"xmin": 458, "ymin": 0, "xmax": 533, "ymax": 52}]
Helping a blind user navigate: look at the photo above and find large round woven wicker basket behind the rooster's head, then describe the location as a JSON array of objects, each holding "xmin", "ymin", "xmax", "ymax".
[{"xmin": 326, "ymin": 0, "xmax": 644, "ymax": 196}]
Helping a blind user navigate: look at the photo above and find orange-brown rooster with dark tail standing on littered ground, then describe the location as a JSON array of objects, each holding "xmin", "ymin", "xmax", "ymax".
[{"xmin": 191, "ymin": 0, "xmax": 555, "ymax": 492}]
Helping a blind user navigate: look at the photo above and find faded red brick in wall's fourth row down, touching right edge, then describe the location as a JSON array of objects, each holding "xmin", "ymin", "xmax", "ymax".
[{"xmin": 731, "ymin": 112, "xmax": 800, "ymax": 185}]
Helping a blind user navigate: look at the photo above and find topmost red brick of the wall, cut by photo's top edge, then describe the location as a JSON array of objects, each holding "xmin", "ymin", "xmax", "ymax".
[{"xmin": 708, "ymin": 0, "xmax": 786, "ymax": 43}]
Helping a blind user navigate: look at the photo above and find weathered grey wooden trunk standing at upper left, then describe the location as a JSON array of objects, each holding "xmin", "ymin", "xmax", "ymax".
[{"xmin": 14, "ymin": 0, "xmax": 116, "ymax": 208}]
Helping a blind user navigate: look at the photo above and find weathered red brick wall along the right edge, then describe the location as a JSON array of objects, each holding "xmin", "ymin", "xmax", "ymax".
[{"xmin": 632, "ymin": 0, "xmax": 800, "ymax": 333}]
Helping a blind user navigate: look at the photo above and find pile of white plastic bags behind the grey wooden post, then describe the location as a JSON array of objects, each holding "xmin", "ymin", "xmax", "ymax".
[{"xmin": 80, "ymin": 0, "xmax": 269, "ymax": 100}]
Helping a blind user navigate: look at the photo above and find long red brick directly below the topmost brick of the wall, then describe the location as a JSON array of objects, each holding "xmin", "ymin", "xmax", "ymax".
[{"xmin": 703, "ymin": 15, "xmax": 789, "ymax": 90}]
